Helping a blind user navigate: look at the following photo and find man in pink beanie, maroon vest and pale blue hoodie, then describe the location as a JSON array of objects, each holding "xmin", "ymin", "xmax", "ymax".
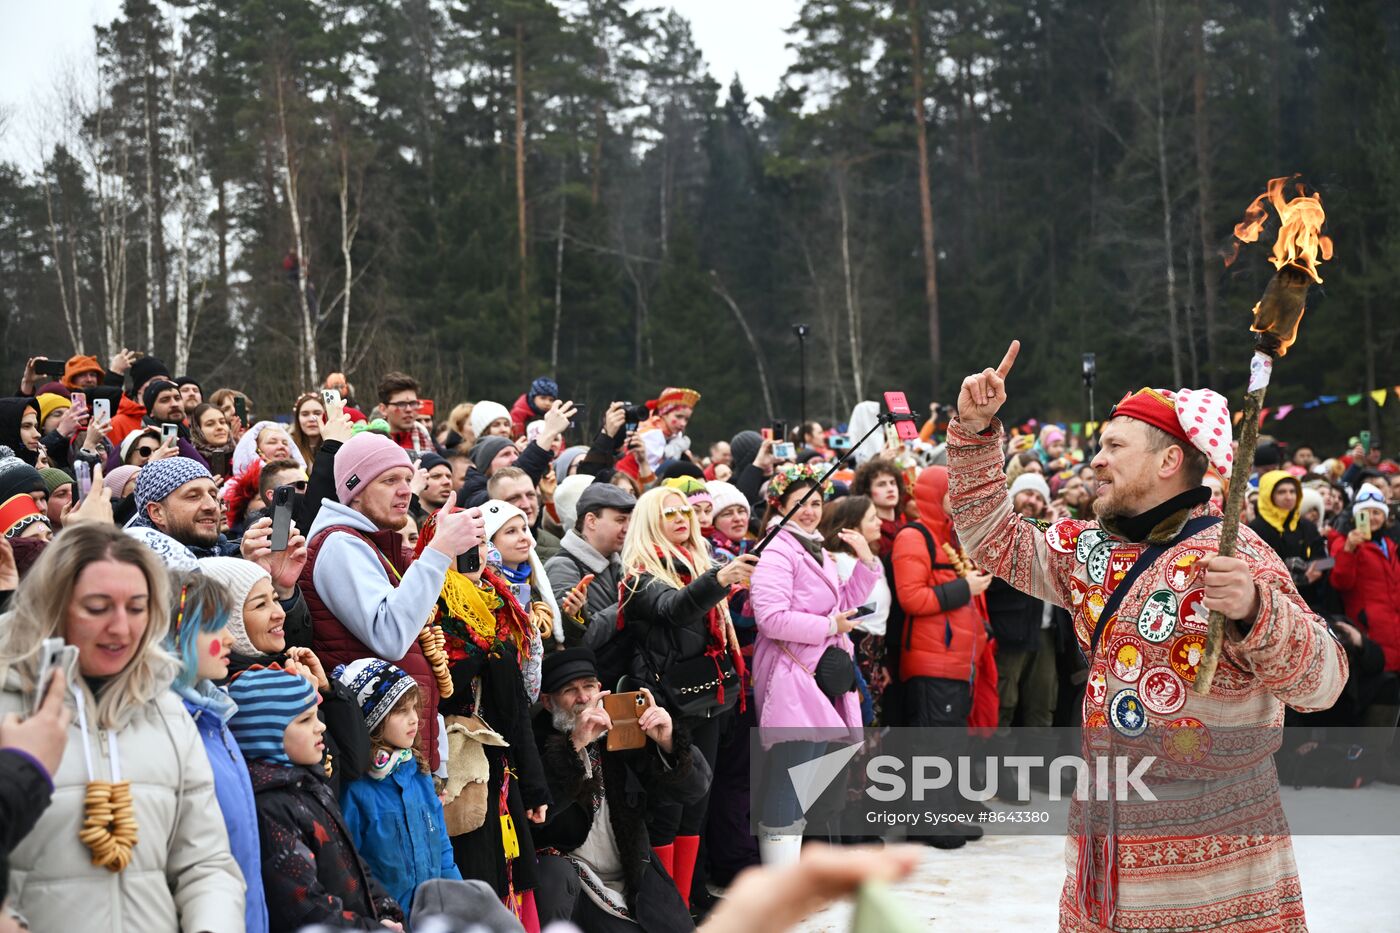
[{"xmin": 301, "ymin": 431, "xmax": 484, "ymax": 769}]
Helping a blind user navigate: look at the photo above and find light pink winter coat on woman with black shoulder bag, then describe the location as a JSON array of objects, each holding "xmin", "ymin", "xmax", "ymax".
[{"xmin": 749, "ymin": 528, "xmax": 879, "ymax": 747}]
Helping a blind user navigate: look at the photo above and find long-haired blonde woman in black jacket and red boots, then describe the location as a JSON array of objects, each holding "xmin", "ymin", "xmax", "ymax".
[{"xmin": 622, "ymin": 486, "xmax": 757, "ymax": 905}]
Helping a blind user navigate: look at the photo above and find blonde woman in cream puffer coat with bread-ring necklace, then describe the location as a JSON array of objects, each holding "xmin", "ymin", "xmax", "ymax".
[{"xmin": 0, "ymin": 524, "xmax": 244, "ymax": 933}]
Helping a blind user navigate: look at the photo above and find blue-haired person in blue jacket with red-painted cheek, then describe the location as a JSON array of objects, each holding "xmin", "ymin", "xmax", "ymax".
[{"xmin": 165, "ymin": 573, "xmax": 269, "ymax": 933}]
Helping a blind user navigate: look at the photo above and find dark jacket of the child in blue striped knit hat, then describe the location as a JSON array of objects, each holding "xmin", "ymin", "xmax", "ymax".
[{"xmin": 248, "ymin": 761, "xmax": 403, "ymax": 930}]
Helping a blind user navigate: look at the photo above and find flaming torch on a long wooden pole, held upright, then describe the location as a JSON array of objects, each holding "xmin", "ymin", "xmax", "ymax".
[{"xmin": 1191, "ymin": 178, "xmax": 1331, "ymax": 696}]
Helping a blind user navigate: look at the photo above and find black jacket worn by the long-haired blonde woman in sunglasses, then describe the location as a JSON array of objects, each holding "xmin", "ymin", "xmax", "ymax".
[{"xmin": 622, "ymin": 567, "xmax": 729, "ymax": 684}]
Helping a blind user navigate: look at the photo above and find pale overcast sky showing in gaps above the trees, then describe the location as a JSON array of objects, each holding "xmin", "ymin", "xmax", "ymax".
[{"xmin": 0, "ymin": 0, "xmax": 799, "ymax": 167}]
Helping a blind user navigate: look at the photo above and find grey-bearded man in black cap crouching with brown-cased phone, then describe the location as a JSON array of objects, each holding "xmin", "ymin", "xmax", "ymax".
[{"xmin": 531, "ymin": 647, "xmax": 710, "ymax": 933}]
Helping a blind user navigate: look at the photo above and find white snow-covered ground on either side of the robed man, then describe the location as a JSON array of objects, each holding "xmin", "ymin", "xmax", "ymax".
[{"xmin": 798, "ymin": 785, "xmax": 1400, "ymax": 933}]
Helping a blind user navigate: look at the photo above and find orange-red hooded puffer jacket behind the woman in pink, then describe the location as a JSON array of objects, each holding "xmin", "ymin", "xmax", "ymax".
[{"xmin": 893, "ymin": 467, "xmax": 994, "ymax": 682}]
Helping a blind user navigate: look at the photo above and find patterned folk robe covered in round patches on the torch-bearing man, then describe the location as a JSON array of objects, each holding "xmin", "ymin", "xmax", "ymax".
[{"xmin": 948, "ymin": 420, "xmax": 1347, "ymax": 933}]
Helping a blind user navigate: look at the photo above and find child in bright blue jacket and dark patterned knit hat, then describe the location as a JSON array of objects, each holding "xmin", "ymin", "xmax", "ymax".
[{"xmin": 335, "ymin": 657, "xmax": 462, "ymax": 915}]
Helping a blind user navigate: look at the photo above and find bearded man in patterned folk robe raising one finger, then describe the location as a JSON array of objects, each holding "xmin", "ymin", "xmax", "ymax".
[{"xmin": 948, "ymin": 340, "xmax": 1347, "ymax": 932}]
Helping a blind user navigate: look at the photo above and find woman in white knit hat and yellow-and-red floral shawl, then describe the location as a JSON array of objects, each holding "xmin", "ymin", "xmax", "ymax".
[{"xmin": 417, "ymin": 500, "xmax": 568, "ymax": 930}]
